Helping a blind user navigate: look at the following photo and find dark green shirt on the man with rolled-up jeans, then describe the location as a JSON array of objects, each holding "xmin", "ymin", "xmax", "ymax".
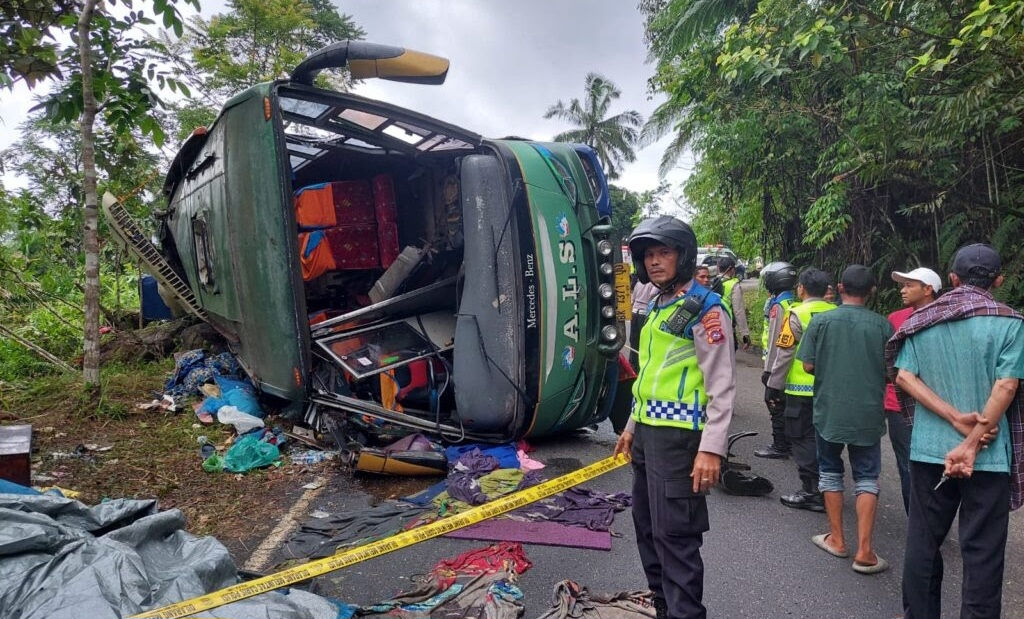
[{"xmin": 795, "ymin": 305, "xmax": 893, "ymax": 447}]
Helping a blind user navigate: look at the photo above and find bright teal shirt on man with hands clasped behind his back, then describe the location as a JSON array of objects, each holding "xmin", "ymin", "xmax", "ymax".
[{"xmin": 896, "ymin": 316, "xmax": 1024, "ymax": 472}]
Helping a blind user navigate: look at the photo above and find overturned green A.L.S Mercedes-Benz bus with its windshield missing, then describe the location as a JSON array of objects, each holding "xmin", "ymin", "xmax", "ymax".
[{"xmin": 149, "ymin": 42, "xmax": 628, "ymax": 441}]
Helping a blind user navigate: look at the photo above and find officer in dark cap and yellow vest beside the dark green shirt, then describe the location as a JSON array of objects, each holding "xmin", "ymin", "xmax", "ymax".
[{"xmin": 765, "ymin": 266, "xmax": 836, "ymax": 511}]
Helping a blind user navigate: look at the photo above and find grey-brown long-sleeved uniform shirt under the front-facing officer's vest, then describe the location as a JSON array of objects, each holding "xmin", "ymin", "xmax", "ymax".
[{"xmin": 625, "ymin": 281, "xmax": 736, "ymax": 458}]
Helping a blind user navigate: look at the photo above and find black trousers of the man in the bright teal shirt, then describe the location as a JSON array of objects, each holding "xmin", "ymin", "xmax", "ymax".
[{"xmin": 903, "ymin": 460, "xmax": 1010, "ymax": 619}]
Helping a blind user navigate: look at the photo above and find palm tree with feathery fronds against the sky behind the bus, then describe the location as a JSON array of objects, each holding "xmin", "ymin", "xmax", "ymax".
[{"xmin": 544, "ymin": 73, "xmax": 643, "ymax": 178}]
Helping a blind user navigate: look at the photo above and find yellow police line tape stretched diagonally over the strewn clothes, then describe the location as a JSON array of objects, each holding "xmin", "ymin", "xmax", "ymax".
[{"xmin": 132, "ymin": 456, "xmax": 627, "ymax": 619}]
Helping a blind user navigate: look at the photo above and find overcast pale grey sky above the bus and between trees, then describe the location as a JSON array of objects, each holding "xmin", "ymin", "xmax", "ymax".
[{"xmin": 0, "ymin": 0, "xmax": 692, "ymax": 207}]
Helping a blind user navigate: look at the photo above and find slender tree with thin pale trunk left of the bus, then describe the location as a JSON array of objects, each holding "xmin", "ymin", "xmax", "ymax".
[{"xmin": 0, "ymin": 0, "xmax": 198, "ymax": 393}]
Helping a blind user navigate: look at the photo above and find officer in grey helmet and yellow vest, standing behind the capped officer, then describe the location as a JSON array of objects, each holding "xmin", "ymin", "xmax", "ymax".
[{"xmin": 754, "ymin": 261, "xmax": 800, "ymax": 459}]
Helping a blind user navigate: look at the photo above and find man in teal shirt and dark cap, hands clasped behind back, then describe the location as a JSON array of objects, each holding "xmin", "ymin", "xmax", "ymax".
[{"xmin": 886, "ymin": 243, "xmax": 1024, "ymax": 619}]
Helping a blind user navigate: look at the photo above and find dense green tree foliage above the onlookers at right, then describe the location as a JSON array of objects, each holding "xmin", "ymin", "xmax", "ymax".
[{"xmin": 645, "ymin": 0, "xmax": 1024, "ymax": 304}]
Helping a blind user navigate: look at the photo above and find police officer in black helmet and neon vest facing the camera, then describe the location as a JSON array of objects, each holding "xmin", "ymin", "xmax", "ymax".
[{"xmin": 615, "ymin": 215, "xmax": 735, "ymax": 619}]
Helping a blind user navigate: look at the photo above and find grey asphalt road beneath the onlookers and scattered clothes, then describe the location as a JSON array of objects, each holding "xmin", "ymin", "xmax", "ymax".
[{"xmin": 276, "ymin": 344, "xmax": 1024, "ymax": 619}]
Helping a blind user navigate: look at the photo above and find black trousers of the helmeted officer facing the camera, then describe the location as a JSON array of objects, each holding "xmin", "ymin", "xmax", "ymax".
[{"xmin": 632, "ymin": 423, "xmax": 709, "ymax": 619}]
